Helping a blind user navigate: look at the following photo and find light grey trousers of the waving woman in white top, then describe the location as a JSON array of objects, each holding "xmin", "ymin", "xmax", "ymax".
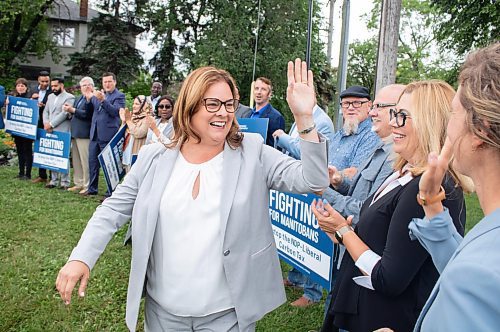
[{"xmin": 144, "ymin": 296, "xmax": 255, "ymax": 332}]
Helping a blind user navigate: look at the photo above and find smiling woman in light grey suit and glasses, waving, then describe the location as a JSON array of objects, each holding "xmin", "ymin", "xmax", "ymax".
[{"xmin": 56, "ymin": 59, "xmax": 328, "ymax": 331}]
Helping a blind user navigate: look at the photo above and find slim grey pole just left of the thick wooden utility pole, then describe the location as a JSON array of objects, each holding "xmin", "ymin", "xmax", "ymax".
[{"xmin": 335, "ymin": 0, "xmax": 351, "ymax": 130}]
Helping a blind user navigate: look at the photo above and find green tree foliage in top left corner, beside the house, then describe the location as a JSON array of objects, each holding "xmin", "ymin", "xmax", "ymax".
[{"xmin": 0, "ymin": 0, "xmax": 60, "ymax": 77}]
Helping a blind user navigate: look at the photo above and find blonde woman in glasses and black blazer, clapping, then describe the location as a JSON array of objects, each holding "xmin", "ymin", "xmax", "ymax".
[{"xmin": 313, "ymin": 81, "xmax": 465, "ymax": 332}]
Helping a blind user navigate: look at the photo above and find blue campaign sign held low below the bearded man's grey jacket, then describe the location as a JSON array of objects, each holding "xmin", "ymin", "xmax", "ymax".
[{"xmin": 33, "ymin": 128, "xmax": 71, "ymax": 174}]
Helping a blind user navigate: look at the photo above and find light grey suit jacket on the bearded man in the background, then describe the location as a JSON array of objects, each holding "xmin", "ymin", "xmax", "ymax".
[{"xmin": 43, "ymin": 91, "xmax": 75, "ymax": 132}]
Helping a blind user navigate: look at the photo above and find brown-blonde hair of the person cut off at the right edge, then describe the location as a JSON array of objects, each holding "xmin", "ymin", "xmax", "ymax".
[{"xmin": 458, "ymin": 42, "xmax": 500, "ymax": 152}]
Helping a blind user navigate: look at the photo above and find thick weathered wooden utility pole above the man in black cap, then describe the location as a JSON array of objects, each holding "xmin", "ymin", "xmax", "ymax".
[{"xmin": 374, "ymin": 0, "xmax": 401, "ymax": 95}]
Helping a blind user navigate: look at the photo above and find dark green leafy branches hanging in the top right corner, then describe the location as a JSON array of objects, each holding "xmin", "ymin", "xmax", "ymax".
[{"xmin": 431, "ymin": 0, "xmax": 500, "ymax": 55}]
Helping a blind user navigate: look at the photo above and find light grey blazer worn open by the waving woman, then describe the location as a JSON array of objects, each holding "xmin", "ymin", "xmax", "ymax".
[{"xmin": 69, "ymin": 133, "xmax": 329, "ymax": 331}]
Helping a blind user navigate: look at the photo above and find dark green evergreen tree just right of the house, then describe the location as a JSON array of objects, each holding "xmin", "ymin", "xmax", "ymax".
[{"xmin": 68, "ymin": 13, "xmax": 143, "ymax": 87}]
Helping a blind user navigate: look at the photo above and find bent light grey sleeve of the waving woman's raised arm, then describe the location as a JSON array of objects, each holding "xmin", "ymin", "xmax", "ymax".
[{"xmin": 261, "ymin": 135, "xmax": 329, "ymax": 193}]
